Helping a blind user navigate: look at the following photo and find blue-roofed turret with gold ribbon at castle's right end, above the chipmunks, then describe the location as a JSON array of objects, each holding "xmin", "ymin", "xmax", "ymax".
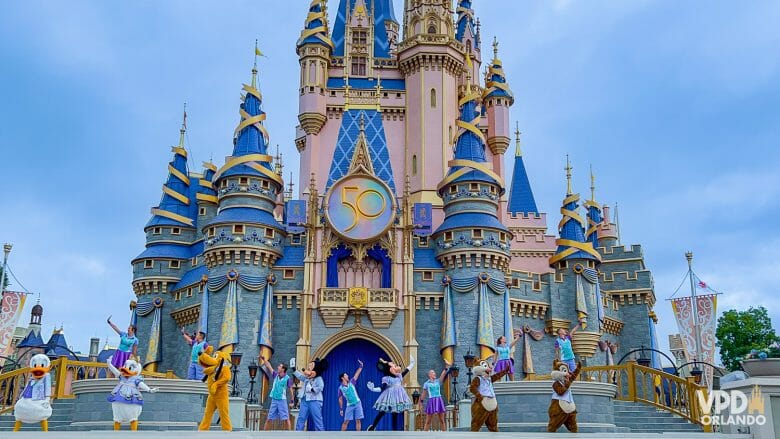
[{"xmin": 547, "ymin": 156, "xmax": 602, "ymax": 364}]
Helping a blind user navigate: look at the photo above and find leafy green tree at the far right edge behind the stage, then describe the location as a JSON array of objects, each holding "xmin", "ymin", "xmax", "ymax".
[{"xmin": 715, "ymin": 306, "xmax": 780, "ymax": 370}]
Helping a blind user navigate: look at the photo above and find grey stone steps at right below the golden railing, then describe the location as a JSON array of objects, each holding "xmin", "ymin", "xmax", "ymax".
[{"xmin": 613, "ymin": 401, "xmax": 702, "ymax": 433}]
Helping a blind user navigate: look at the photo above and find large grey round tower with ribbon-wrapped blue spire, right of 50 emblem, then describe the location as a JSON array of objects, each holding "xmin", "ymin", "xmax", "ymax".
[{"xmin": 433, "ymin": 75, "xmax": 511, "ymax": 360}]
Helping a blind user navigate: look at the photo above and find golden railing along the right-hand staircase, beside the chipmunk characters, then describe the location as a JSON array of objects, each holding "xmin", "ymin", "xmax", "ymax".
[{"xmin": 580, "ymin": 361, "xmax": 712, "ymax": 432}]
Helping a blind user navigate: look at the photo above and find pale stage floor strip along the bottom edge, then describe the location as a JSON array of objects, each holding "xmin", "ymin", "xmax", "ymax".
[{"xmin": 3, "ymin": 431, "xmax": 751, "ymax": 439}]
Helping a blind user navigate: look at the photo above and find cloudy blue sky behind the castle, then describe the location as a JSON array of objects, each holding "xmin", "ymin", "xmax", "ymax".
[{"xmin": 0, "ymin": 0, "xmax": 780, "ymax": 362}]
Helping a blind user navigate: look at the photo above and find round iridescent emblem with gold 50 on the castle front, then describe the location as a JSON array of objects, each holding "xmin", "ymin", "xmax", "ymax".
[{"xmin": 325, "ymin": 175, "xmax": 395, "ymax": 241}]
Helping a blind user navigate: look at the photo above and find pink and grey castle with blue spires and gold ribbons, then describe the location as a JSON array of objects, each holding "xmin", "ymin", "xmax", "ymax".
[{"xmin": 131, "ymin": 0, "xmax": 657, "ymax": 430}]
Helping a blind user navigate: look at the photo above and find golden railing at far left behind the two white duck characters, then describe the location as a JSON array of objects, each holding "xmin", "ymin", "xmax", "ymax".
[{"xmin": 0, "ymin": 357, "xmax": 177, "ymax": 414}]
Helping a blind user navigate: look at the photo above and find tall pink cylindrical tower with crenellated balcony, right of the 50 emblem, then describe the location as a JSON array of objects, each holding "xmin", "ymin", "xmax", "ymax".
[{"xmin": 398, "ymin": 0, "xmax": 464, "ymax": 211}]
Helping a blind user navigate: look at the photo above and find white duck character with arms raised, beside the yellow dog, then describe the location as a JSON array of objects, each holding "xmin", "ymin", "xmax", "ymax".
[{"xmin": 106, "ymin": 360, "xmax": 157, "ymax": 431}]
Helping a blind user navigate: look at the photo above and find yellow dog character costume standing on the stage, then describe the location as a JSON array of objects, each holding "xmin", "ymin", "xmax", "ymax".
[{"xmin": 198, "ymin": 346, "xmax": 233, "ymax": 431}]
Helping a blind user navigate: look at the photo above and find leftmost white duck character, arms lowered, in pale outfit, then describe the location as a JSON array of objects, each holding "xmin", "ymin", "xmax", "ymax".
[{"xmin": 14, "ymin": 354, "xmax": 51, "ymax": 431}]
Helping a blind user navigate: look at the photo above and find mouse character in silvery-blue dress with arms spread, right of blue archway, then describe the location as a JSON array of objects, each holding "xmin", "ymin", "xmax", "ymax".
[{"xmin": 366, "ymin": 356, "xmax": 415, "ymax": 431}]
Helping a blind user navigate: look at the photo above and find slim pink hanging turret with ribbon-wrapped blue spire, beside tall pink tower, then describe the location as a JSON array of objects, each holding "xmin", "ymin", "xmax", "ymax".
[{"xmin": 483, "ymin": 38, "xmax": 515, "ymax": 177}]
